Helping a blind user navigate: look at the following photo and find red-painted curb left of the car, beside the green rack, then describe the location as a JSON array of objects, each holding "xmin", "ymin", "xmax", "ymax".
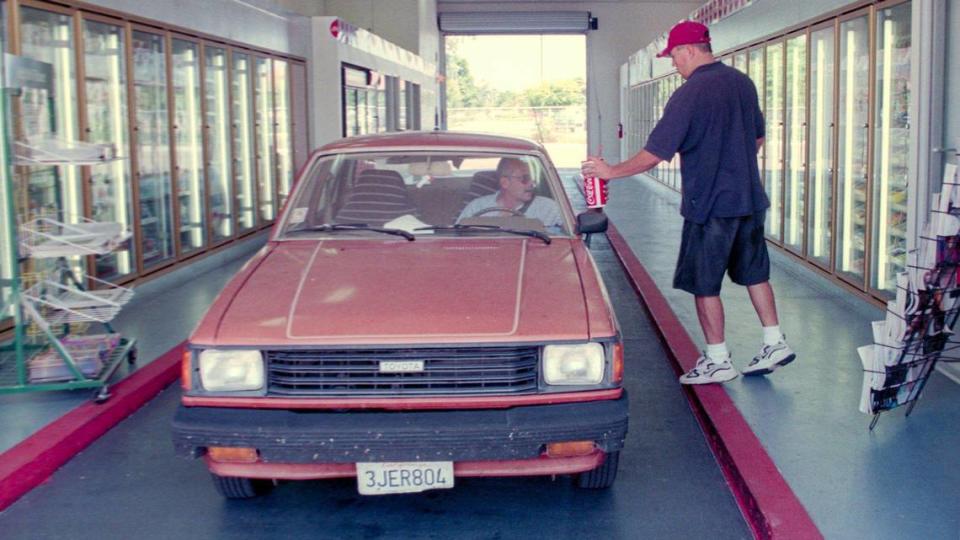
[{"xmin": 0, "ymin": 343, "xmax": 183, "ymax": 511}]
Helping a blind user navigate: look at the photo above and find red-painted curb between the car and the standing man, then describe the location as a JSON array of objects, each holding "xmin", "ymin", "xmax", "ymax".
[{"xmin": 607, "ymin": 223, "xmax": 823, "ymax": 539}]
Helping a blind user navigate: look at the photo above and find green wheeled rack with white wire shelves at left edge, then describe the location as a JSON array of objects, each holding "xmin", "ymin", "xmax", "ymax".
[{"xmin": 0, "ymin": 55, "xmax": 136, "ymax": 402}]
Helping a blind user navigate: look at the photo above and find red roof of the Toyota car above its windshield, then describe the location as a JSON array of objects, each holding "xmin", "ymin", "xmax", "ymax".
[{"xmin": 317, "ymin": 131, "xmax": 545, "ymax": 153}]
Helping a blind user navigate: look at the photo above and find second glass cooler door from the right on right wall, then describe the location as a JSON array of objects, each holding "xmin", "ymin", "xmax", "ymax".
[{"xmin": 835, "ymin": 15, "xmax": 870, "ymax": 282}]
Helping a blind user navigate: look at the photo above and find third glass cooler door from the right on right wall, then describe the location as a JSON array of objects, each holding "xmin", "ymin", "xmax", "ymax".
[{"xmin": 807, "ymin": 26, "xmax": 836, "ymax": 267}]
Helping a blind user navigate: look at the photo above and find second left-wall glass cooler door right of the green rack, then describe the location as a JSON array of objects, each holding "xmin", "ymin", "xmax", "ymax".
[{"xmin": 170, "ymin": 38, "xmax": 207, "ymax": 254}]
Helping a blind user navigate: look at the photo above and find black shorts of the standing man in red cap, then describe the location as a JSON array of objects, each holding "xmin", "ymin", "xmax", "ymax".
[{"xmin": 673, "ymin": 212, "xmax": 770, "ymax": 296}]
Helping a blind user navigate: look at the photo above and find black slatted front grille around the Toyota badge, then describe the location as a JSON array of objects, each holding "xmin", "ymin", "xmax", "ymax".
[{"xmin": 265, "ymin": 347, "xmax": 539, "ymax": 396}]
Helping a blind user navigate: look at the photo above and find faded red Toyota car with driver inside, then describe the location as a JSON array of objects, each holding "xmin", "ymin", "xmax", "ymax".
[{"xmin": 173, "ymin": 132, "xmax": 627, "ymax": 498}]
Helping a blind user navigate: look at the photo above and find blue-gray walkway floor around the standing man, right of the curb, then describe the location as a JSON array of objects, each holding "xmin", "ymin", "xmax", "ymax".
[{"xmin": 606, "ymin": 174, "xmax": 960, "ymax": 540}]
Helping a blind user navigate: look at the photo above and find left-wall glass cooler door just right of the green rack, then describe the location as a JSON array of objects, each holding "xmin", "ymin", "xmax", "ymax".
[{"xmin": 132, "ymin": 30, "xmax": 174, "ymax": 268}]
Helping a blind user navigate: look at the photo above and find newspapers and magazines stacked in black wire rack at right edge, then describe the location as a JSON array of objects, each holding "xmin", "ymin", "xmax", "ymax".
[{"xmin": 857, "ymin": 164, "xmax": 960, "ymax": 414}]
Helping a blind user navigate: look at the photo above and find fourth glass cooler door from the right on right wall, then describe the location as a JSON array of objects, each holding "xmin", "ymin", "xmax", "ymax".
[{"xmin": 783, "ymin": 34, "xmax": 807, "ymax": 253}]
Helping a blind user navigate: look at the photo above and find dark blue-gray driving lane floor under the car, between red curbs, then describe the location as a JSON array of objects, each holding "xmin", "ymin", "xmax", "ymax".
[{"xmin": 0, "ymin": 232, "xmax": 750, "ymax": 540}]
